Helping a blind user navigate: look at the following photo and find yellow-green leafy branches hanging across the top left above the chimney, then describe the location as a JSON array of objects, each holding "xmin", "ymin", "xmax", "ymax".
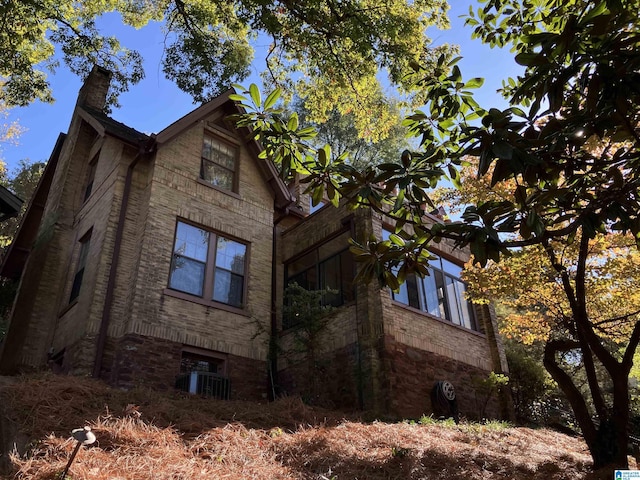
[{"xmin": 0, "ymin": 0, "xmax": 451, "ymax": 135}]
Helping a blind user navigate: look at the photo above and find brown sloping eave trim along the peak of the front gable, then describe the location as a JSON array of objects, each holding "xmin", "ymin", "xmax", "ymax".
[{"xmin": 156, "ymin": 88, "xmax": 295, "ymax": 209}]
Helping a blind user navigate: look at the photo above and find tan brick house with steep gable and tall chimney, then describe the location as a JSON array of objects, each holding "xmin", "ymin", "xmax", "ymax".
[{"xmin": 0, "ymin": 67, "xmax": 508, "ymax": 416}]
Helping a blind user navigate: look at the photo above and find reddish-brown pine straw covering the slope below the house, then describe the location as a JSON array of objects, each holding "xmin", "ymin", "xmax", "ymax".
[{"xmin": 0, "ymin": 376, "xmax": 590, "ymax": 480}]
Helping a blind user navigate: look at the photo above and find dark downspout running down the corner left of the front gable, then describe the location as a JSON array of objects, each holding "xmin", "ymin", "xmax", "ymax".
[{"xmin": 92, "ymin": 135, "xmax": 156, "ymax": 378}]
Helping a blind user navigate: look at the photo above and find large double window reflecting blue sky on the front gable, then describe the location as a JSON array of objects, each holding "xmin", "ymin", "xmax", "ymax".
[{"xmin": 169, "ymin": 222, "xmax": 247, "ymax": 308}]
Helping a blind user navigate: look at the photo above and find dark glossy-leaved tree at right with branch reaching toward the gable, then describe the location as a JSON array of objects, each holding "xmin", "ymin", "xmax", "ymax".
[{"xmin": 236, "ymin": 0, "xmax": 640, "ymax": 468}]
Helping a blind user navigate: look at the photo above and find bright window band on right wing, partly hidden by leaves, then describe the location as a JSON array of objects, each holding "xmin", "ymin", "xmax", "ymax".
[{"xmin": 383, "ymin": 230, "xmax": 477, "ymax": 330}]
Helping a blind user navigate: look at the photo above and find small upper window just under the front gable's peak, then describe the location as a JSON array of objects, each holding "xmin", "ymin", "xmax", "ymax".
[{"xmin": 200, "ymin": 133, "xmax": 238, "ymax": 190}]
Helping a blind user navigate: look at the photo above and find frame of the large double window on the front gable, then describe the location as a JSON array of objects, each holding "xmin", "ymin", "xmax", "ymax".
[{"xmin": 164, "ymin": 218, "xmax": 250, "ymax": 314}]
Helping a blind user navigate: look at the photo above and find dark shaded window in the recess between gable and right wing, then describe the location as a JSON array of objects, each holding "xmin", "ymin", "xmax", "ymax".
[{"xmin": 284, "ymin": 231, "xmax": 355, "ymax": 328}]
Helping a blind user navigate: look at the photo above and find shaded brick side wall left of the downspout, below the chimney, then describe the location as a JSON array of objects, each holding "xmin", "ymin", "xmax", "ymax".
[{"xmin": 2, "ymin": 116, "xmax": 122, "ymax": 369}]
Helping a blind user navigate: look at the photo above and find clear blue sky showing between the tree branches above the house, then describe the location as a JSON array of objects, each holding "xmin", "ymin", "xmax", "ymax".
[{"xmin": 1, "ymin": 0, "xmax": 521, "ymax": 171}]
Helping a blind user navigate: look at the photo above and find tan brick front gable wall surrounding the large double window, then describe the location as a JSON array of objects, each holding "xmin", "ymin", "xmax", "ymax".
[{"xmin": 110, "ymin": 113, "xmax": 273, "ymax": 368}]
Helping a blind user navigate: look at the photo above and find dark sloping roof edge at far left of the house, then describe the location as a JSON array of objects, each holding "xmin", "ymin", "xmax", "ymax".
[{"xmin": 0, "ymin": 133, "xmax": 67, "ymax": 279}]
